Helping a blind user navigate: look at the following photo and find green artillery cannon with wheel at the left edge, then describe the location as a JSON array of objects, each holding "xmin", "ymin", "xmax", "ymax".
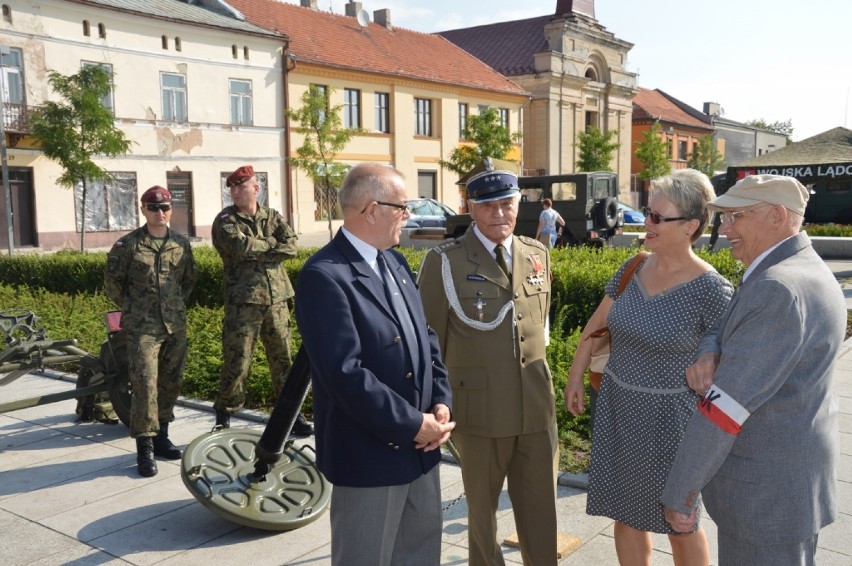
[{"xmin": 0, "ymin": 309, "xmax": 131, "ymax": 425}]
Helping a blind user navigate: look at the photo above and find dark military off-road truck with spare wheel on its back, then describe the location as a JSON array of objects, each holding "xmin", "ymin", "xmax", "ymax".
[{"xmin": 446, "ymin": 171, "xmax": 624, "ymax": 245}]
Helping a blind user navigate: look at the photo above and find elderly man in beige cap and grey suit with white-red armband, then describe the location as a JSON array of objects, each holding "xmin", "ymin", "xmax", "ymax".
[{"xmin": 662, "ymin": 175, "xmax": 846, "ymax": 566}]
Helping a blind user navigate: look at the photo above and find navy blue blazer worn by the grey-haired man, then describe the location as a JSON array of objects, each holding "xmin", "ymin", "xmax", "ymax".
[{"xmin": 295, "ymin": 231, "xmax": 452, "ymax": 487}]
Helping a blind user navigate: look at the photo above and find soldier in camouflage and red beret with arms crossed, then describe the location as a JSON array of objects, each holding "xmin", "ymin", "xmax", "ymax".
[{"xmin": 212, "ymin": 165, "xmax": 313, "ymax": 435}]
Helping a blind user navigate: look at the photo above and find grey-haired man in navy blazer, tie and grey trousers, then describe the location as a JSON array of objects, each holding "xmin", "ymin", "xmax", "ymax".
[{"xmin": 295, "ymin": 163, "xmax": 455, "ymax": 566}]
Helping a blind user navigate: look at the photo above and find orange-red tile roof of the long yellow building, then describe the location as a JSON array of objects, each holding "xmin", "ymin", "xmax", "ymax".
[{"xmin": 228, "ymin": 0, "xmax": 529, "ymax": 96}]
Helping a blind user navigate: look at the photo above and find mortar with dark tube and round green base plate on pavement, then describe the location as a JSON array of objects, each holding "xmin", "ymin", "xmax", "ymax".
[{"xmin": 181, "ymin": 349, "xmax": 331, "ymax": 531}]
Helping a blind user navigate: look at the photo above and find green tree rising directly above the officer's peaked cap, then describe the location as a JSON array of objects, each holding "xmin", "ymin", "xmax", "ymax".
[{"xmin": 438, "ymin": 106, "xmax": 521, "ymax": 175}]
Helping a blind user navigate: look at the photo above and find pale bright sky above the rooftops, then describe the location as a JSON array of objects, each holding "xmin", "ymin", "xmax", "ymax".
[{"xmin": 320, "ymin": 0, "xmax": 852, "ymax": 141}]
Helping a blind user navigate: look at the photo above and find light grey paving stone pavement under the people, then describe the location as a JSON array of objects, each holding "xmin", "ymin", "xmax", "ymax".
[{"xmin": 0, "ymin": 356, "xmax": 852, "ymax": 566}]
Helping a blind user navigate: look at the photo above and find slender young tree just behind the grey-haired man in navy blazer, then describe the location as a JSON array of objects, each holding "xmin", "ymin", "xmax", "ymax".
[{"xmin": 287, "ymin": 85, "xmax": 362, "ymax": 240}]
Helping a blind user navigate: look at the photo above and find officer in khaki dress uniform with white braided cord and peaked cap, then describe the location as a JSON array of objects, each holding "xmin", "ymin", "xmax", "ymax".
[{"xmin": 419, "ymin": 160, "xmax": 558, "ymax": 566}]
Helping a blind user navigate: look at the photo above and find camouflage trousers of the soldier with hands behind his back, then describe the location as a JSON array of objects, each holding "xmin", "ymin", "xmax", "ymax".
[{"xmin": 126, "ymin": 329, "xmax": 187, "ymax": 438}]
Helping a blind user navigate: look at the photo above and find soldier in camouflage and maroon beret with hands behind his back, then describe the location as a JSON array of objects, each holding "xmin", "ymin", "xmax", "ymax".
[{"xmin": 104, "ymin": 186, "xmax": 196, "ymax": 477}]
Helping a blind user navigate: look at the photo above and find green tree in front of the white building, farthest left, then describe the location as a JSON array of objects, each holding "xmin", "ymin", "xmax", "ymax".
[{"xmin": 31, "ymin": 65, "xmax": 131, "ymax": 251}]
